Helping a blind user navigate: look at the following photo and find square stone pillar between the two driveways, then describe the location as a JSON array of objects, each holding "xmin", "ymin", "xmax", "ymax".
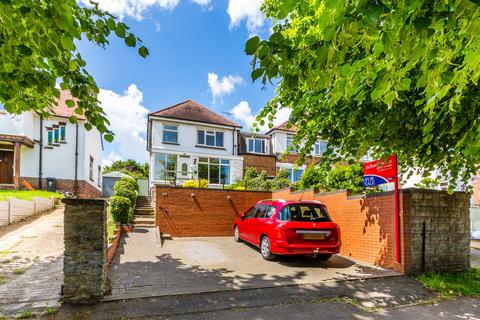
[{"xmin": 63, "ymin": 199, "xmax": 107, "ymax": 303}]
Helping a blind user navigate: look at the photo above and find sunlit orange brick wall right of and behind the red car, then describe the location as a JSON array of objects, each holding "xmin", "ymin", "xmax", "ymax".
[{"xmin": 272, "ymin": 189, "xmax": 403, "ymax": 271}]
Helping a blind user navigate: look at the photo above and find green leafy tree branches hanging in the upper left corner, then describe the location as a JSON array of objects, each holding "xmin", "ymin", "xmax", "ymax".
[{"xmin": 0, "ymin": 0, "xmax": 148, "ymax": 141}]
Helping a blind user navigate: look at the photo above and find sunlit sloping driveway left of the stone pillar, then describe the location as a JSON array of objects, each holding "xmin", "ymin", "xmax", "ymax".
[{"xmin": 0, "ymin": 209, "xmax": 63, "ymax": 314}]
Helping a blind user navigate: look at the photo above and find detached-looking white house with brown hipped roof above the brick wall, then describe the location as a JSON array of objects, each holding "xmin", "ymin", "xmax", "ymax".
[{"xmin": 147, "ymin": 100, "xmax": 243, "ymax": 187}]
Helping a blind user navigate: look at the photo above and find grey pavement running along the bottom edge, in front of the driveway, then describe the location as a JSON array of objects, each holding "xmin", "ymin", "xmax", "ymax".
[{"xmin": 51, "ymin": 276, "xmax": 480, "ymax": 320}]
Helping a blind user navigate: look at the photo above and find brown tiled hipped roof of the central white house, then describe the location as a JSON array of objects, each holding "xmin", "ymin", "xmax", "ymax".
[{"xmin": 150, "ymin": 100, "xmax": 242, "ymax": 128}]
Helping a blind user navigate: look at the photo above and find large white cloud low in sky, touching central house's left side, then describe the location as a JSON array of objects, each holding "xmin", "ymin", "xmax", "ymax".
[{"xmin": 98, "ymin": 84, "xmax": 148, "ymax": 162}]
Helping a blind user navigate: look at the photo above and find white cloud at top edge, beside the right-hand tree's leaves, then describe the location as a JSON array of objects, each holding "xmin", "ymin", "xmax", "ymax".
[{"xmin": 227, "ymin": 0, "xmax": 265, "ymax": 33}]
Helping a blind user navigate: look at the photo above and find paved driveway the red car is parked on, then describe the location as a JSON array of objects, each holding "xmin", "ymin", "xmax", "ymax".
[{"xmin": 106, "ymin": 228, "xmax": 396, "ymax": 300}]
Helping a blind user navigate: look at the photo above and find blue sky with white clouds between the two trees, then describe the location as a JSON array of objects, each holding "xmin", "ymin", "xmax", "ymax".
[{"xmin": 78, "ymin": 0, "xmax": 286, "ymax": 164}]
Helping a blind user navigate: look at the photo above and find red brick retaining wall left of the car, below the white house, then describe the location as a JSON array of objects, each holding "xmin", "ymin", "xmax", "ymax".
[{"xmin": 156, "ymin": 186, "xmax": 272, "ymax": 237}]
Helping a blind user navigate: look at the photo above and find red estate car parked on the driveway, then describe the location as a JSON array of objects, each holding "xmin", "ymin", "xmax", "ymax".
[{"xmin": 234, "ymin": 200, "xmax": 341, "ymax": 260}]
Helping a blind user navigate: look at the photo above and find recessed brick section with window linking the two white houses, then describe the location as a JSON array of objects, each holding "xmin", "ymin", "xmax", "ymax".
[{"xmin": 238, "ymin": 132, "xmax": 277, "ymax": 177}]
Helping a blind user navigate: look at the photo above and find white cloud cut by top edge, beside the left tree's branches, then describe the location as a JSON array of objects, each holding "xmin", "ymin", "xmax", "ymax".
[{"xmin": 80, "ymin": 0, "xmax": 180, "ymax": 20}]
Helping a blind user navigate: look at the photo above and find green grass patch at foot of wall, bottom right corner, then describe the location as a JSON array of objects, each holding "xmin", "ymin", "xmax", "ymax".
[{"xmin": 415, "ymin": 268, "xmax": 480, "ymax": 298}]
